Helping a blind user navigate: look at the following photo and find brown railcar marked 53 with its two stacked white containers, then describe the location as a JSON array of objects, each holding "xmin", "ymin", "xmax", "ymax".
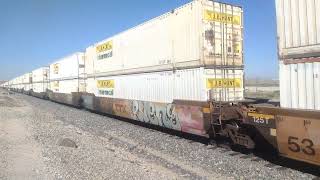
[{"xmin": 244, "ymin": 0, "xmax": 320, "ymax": 165}]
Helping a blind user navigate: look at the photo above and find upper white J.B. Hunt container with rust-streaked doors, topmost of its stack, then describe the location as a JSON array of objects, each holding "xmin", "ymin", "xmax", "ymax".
[{"xmin": 86, "ymin": 0, "xmax": 243, "ymax": 77}]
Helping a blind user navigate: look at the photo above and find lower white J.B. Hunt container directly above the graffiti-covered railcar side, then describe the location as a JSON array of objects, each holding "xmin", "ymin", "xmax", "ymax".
[{"xmin": 87, "ymin": 68, "xmax": 243, "ymax": 103}]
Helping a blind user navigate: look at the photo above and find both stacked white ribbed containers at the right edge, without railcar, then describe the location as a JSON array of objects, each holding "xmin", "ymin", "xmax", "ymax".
[{"xmin": 276, "ymin": 0, "xmax": 320, "ymax": 110}]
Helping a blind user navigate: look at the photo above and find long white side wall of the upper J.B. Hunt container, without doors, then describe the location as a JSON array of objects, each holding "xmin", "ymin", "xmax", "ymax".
[{"xmin": 85, "ymin": 1, "xmax": 201, "ymax": 73}]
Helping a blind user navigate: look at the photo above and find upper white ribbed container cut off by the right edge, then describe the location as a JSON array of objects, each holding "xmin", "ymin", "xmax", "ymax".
[{"xmin": 276, "ymin": 0, "xmax": 320, "ymax": 58}]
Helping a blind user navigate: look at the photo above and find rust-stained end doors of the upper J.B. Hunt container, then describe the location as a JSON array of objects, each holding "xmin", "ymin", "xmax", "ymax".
[{"xmin": 203, "ymin": 1, "xmax": 243, "ymax": 66}]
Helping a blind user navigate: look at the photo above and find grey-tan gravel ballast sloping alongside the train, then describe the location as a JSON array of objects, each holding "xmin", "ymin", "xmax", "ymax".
[{"xmin": 0, "ymin": 89, "xmax": 316, "ymax": 179}]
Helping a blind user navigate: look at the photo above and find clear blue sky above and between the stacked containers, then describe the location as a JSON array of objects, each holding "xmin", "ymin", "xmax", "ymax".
[{"xmin": 0, "ymin": 0, "xmax": 278, "ymax": 80}]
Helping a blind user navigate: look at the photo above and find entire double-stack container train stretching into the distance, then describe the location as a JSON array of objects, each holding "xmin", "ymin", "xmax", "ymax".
[{"xmin": 2, "ymin": 0, "xmax": 320, "ymax": 165}]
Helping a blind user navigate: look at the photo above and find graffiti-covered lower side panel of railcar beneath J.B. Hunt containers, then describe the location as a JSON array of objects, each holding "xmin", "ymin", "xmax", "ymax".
[{"xmin": 95, "ymin": 97, "xmax": 205, "ymax": 135}]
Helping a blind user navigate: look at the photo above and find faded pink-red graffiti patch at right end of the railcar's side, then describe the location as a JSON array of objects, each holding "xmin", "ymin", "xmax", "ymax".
[{"xmin": 176, "ymin": 105, "xmax": 206, "ymax": 135}]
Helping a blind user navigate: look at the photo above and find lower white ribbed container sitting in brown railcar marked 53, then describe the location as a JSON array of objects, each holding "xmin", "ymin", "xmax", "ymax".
[{"xmin": 280, "ymin": 61, "xmax": 320, "ymax": 110}]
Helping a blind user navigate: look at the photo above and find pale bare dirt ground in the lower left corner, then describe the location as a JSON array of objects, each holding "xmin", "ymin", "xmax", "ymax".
[{"xmin": 0, "ymin": 95, "xmax": 46, "ymax": 179}]
